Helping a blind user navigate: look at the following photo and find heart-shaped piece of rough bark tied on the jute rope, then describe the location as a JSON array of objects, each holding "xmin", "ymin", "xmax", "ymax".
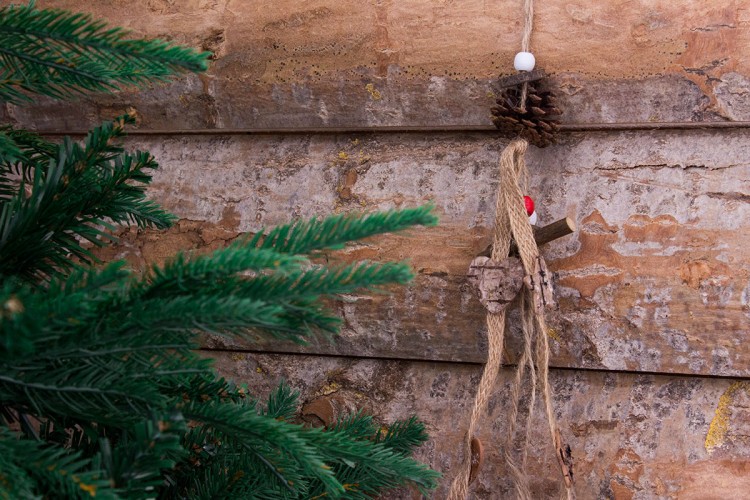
[{"xmin": 467, "ymin": 256, "xmax": 524, "ymax": 314}]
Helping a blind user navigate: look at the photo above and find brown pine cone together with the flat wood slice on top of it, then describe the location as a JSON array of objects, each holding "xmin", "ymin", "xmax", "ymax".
[{"xmin": 491, "ymin": 70, "xmax": 562, "ymax": 148}]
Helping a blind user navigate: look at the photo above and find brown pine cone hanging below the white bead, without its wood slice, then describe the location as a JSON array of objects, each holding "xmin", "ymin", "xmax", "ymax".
[{"xmin": 492, "ymin": 81, "xmax": 562, "ymax": 148}]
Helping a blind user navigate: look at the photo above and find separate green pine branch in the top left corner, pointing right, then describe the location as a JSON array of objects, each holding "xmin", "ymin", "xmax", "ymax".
[{"xmin": 0, "ymin": 2, "xmax": 210, "ymax": 103}]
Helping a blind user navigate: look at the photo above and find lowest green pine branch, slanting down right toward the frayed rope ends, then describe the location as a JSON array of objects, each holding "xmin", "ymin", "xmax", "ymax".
[{"xmin": 181, "ymin": 396, "xmax": 438, "ymax": 499}]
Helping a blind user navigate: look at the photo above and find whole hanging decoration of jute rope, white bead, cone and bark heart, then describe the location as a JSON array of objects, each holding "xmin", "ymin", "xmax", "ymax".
[{"xmin": 448, "ymin": 0, "xmax": 574, "ymax": 500}]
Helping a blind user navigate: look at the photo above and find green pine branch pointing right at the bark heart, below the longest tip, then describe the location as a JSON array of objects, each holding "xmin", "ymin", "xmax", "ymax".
[{"xmin": 131, "ymin": 234, "xmax": 413, "ymax": 342}]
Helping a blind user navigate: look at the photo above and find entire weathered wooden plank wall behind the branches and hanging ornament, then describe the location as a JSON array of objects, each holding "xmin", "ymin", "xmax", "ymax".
[{"xmin": 10, "ymin": 0, "xmax": 750, "ymax": 499}]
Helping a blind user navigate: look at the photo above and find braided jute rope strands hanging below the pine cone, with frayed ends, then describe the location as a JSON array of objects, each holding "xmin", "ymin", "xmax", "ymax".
[{"xmin": 448, "ymin": 139, "xmax": 572, "ymax": 500}]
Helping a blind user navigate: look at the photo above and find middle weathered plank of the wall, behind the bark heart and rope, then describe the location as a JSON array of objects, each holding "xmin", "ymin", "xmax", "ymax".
[{"xmin": 92, "ymin": 131, "xmax": 750, "ymax": 376}]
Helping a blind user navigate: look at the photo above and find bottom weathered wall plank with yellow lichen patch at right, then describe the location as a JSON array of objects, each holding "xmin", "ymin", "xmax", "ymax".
[{"xmin": 204, "ymin": 353, "xmax": 750, "ymax": 500}]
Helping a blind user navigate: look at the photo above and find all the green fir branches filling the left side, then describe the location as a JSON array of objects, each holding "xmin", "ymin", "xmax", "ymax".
[{"xmin": 0, "ymin": 3, "xmax": 438, "ymax": 499}]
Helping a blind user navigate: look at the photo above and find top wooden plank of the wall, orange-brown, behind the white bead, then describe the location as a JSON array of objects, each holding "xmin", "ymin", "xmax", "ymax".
[{"xmin": 10, "ymin": 0, "xmax": 750, "ymax": 130}]
